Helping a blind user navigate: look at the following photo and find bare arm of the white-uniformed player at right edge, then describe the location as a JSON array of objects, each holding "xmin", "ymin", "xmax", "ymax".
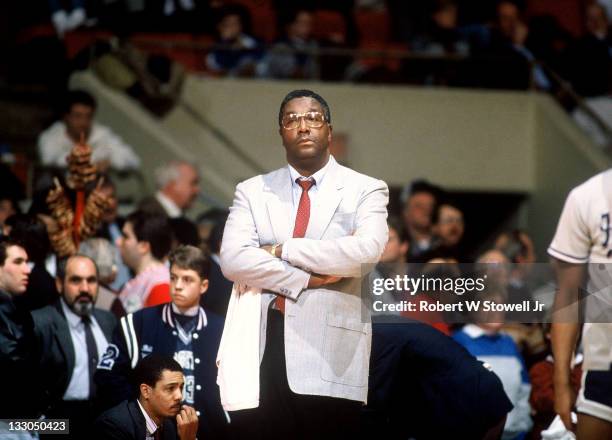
[{"xmin": 551, "ymin": 258, "xmax": 585, "ymax": 429}]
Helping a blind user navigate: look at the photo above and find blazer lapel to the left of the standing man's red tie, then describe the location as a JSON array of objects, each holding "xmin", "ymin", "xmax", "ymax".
[{"xmin": 264, "ymin": 167, "xmax": 293, "ymax": 243}]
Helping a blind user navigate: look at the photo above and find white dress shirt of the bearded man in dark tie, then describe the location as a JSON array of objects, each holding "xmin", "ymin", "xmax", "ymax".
[{"xmin": 61, "ymin": 298, "xmax": 108, "ymax": 400}]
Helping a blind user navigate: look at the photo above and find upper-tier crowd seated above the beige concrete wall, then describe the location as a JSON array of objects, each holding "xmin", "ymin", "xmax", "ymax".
[{"xmin": 4, "ymin": 0, "xmax": 612, "ymax": 92}]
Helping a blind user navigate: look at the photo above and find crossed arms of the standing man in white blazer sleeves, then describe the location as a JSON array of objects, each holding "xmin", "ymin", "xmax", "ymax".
[{"xmin": 221, "ymin": 181, "xmax": 388, "ymax": 299}]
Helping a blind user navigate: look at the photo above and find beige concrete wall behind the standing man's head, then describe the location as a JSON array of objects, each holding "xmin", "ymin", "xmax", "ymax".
[{"xmin": 73, "ymin": 74, "xmax": 610, "ymax": 260}]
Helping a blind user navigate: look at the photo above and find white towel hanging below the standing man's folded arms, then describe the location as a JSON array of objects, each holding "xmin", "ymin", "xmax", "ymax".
[{"xmin": 217, "ymin": 284, "xmax": 261, "ymax": 411}]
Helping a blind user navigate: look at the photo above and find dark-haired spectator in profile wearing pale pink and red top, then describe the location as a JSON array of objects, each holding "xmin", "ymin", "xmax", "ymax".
[{"xmin": 117, "ymin": 211, "xmax": 172, "ymax": 313}]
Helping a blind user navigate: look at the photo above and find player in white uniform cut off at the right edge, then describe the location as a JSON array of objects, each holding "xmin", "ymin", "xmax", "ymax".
[{"xmin": 548, "ymin": 170, "xmax": 612, "ymax": 440}]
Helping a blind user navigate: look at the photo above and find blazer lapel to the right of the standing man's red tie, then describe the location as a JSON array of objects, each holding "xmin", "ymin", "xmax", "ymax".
[{"xmin": 306, "ymin": 157, "xmax": 344, "ymax": 240}]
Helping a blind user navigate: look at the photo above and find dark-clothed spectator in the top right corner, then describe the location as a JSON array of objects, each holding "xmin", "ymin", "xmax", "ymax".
[{"xmin": 567, "ymin": 2, "xmax": 612, "ymax": 96}]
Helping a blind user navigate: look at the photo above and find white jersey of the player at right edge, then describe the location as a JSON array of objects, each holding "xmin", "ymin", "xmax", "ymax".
[{"xmin": 548, "ymin": 170, "xmax": 612, "ymax": 370}]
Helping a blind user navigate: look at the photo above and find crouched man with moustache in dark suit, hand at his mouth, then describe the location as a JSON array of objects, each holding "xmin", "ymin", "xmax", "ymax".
[{"xmin": 93, "ymin": 353, "xmax": 198, "ymax": 440}]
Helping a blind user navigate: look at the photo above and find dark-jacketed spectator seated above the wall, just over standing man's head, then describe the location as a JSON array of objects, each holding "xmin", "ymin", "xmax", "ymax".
[{"xmin": 260, "ymin": 9, "xmax": 319, "ymax": 79}]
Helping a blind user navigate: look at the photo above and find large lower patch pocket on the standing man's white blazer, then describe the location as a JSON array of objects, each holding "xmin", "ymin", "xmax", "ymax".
[{"xmin": 321, "ymin": 315, "xmax": 369, "ymax": 387}]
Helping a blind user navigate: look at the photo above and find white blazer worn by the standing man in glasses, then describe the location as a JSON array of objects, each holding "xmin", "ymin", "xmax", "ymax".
[{"xmin": 220, "ymin": 156, "xmax": 389, "ymax": 402}]
